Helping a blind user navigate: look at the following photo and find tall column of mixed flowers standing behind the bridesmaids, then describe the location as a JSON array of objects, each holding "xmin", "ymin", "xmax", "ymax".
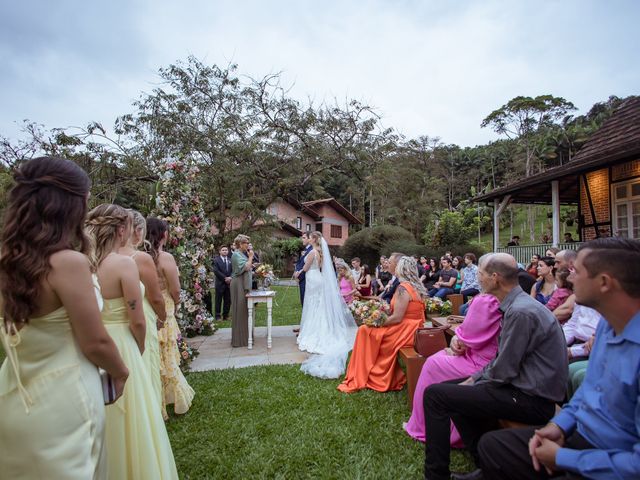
[{"xmin": 154, "ymin": 157, "xmax": 215, "ymax": 337}]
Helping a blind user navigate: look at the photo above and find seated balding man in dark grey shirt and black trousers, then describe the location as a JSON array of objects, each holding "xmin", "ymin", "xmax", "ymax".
[{"xmin": 424, "ymin": 253, "xmax": 568, "ymax": 480}]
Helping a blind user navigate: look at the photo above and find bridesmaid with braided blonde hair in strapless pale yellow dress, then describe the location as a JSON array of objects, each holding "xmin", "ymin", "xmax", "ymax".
[{"xmin": 86, "ymin": 204, "xmax": 178, "ymax": 480}]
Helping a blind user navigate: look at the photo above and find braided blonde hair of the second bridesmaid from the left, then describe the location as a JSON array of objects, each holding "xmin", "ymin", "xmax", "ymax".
[{"xmin": 85, "ymin": 203, "xmax": 132, "ymax": 272}]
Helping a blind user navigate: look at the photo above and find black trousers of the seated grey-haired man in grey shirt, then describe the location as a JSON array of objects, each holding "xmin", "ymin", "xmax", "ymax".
[{"xmin": 423, "ymin": 379, "xmax": 555, "ymax": 480}]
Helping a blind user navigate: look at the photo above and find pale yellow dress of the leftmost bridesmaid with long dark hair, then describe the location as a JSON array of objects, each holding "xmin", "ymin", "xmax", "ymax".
[{"xmin": 0, "ymin": 307, "xmax": 107, "ymax": 480}]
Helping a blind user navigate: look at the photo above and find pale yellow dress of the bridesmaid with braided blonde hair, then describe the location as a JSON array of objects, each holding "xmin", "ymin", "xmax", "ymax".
[{"xmin": 102, "ymin": 298, "xmax": 178, "ymax": 480}]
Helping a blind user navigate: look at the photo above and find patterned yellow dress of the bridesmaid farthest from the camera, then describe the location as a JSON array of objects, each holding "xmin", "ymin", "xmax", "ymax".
[{"xmin": 158, "ymin": 290, "xmax": 195, "ymax": 420}]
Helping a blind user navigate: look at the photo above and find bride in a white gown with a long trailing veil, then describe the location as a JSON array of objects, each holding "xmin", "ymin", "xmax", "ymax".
[{"xmin": 298, "ymin": 232, "xmax": 357, "ymax": 378}]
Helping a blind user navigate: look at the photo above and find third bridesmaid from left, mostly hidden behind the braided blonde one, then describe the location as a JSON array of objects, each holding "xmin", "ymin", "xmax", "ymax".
[{"xmin": 118, "ymin": 209, "xmax": 167, "ymax": 406}]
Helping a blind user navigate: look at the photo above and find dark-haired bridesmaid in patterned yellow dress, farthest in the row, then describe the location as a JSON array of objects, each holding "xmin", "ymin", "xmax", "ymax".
[{"xmin": 147, "ymin": 217, "xmax": 195, "ymax": 419}]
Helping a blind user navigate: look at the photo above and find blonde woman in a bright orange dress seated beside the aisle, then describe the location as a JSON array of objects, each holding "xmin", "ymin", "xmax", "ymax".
[{"xmin": 338, "ymin": 257, "xmax": 427, "ymax": 393}]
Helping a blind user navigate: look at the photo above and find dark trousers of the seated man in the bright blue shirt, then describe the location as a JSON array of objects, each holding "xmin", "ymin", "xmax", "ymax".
[{"xmin": 478, "ymin": 427, "xmax": 594, "ymax": 480}]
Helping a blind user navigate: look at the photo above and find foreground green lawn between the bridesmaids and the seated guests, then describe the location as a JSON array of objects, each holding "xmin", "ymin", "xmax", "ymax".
[{"xmin": 167, "ymin": 365, "xmax": 473, "ymax": 479}]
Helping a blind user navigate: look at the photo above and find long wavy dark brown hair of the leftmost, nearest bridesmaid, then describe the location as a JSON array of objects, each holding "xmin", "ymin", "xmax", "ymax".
[{"xmin": 0, "ymin": 157, "xmax": 91, "ymax": 322}]
